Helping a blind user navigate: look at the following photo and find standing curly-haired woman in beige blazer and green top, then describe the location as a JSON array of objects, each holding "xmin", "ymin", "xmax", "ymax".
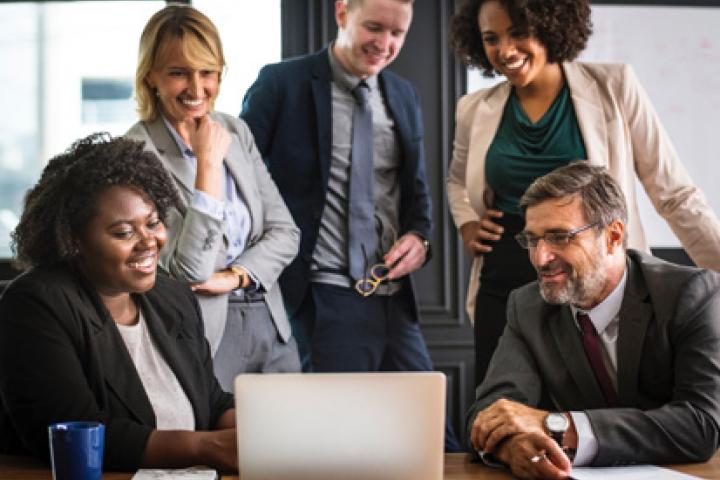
[{"xmin": 448, "ymin": 0, "xmax": 720, "ymax": 384}]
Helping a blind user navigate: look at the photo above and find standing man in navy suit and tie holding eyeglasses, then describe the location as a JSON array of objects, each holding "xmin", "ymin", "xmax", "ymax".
[{"xmin": 241, "ymin": 0, "xmax": 432, "ymax": 382}]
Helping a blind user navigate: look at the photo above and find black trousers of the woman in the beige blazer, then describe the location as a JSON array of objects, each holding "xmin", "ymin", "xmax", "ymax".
[{"xmin": 474, "ymin": 213, "xmax": 537, "ymax": 386}]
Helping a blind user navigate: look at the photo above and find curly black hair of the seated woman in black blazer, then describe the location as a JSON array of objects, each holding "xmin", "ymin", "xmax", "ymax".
[{"xmin": 11, "ymin": 133, "xmax": 179, "ymax": 268}]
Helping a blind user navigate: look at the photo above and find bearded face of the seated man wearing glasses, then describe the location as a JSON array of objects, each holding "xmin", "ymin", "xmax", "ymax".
[{"xmin": 525, "ymin": 195, "xmax": 624, "ymax": 309}]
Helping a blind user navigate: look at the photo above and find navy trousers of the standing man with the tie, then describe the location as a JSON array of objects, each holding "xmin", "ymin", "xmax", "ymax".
[{"xmin": 290, "ymin": 283, "xmax": 460, "ymax": 452}]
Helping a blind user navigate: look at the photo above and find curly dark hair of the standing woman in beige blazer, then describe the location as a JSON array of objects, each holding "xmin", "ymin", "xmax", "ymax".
[{"xmin": 450, "ymin": 0, "xmax": 592, "ymax": 77}]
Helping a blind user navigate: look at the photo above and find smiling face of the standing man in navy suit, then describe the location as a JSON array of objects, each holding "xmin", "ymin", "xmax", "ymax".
[{"xmin": 333, "ymin": 0, "xmax": 412, "ymax": 78}]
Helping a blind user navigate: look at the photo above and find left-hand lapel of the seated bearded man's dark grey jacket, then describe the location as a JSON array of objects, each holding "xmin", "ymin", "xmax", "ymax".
[{"xmin": 549, "ymin": 306, "xmax": 606, "ymax": 409}]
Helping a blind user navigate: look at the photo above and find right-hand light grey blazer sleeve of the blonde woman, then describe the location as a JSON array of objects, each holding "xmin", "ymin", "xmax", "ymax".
[{"xmin": 229, "ymin": 119, "xmax": 300, "ymax": 290}]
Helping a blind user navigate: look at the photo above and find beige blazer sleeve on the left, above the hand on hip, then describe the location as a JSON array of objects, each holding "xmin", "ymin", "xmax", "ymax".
[{"xmin": 447, "ymin": 96, "xmax": 485, "ymax": 228}]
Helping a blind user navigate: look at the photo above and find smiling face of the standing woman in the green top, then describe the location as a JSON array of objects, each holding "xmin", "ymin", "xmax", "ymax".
[{"xmin": 478, "ymin": 0, "xmax": 559, "ymax": 88}]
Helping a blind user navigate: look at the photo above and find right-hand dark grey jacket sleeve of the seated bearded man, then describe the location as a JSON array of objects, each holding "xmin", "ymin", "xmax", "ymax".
[{"xmin": 586, "ymin": 271, "xmax": 720, "ymax": 466}]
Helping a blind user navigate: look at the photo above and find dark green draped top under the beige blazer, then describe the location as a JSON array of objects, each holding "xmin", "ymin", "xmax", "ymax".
[{"xmin": 485, "ymin": 84, "xmax": 587, "ymax": 214}]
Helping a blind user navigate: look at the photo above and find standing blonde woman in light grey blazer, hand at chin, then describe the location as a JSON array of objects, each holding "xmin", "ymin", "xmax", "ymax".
[{"xmin": 127, "ymin": 5, "xmax": 300, "ymax": 391}]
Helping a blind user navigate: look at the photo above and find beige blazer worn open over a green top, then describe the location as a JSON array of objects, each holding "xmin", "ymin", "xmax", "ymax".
[{"xmin": 447, "ymin": 62, "xmax": 720, "ymax": 320}]
